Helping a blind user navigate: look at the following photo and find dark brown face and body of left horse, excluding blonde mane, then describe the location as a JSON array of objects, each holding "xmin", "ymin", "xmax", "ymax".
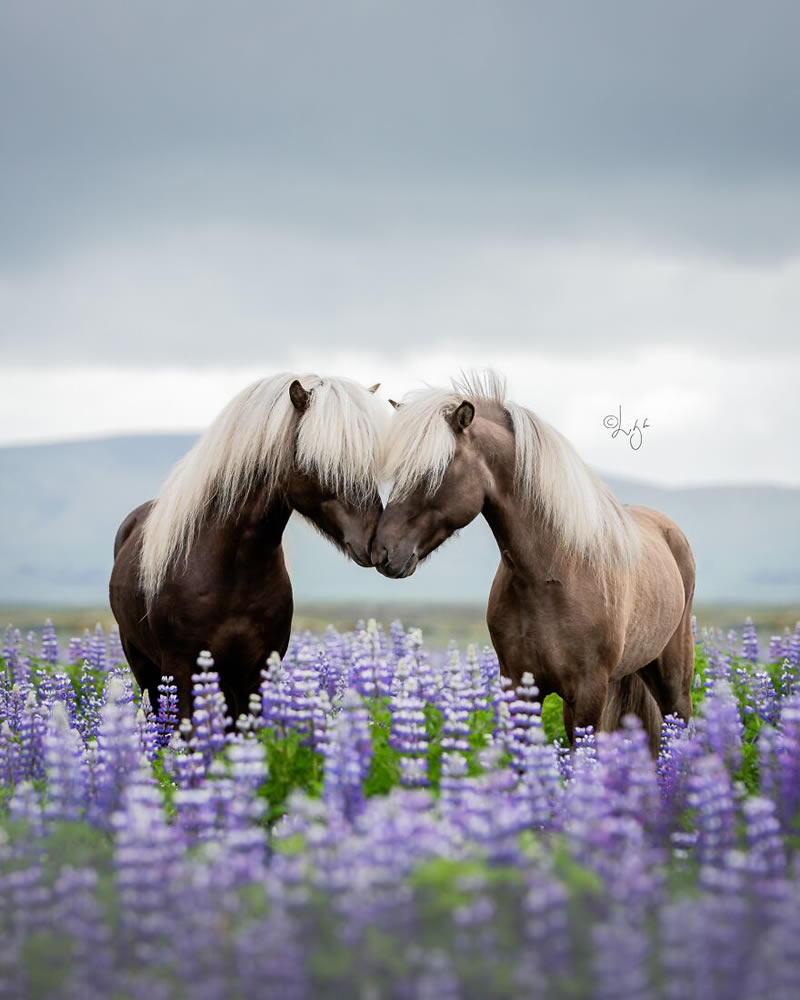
[{"xmin": 109, "ymin": 394, "xmax": 383, "ymax": 720}]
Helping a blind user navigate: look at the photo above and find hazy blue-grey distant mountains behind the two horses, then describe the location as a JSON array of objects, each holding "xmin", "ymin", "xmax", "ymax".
[{"xmin": 0, "ymin": 435, "xmax": 800, "ymax": 606}]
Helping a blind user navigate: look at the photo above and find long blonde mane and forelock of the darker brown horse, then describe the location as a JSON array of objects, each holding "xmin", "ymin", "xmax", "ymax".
[{"xmin": 139, "ymin": 373, "xmax": 386, "ymax": 603}]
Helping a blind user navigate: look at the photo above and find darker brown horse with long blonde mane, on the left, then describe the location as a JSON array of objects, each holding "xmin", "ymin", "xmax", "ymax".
[{"xmin": 109, "ymin": 374, "xmax": 385, "ymax": 719}]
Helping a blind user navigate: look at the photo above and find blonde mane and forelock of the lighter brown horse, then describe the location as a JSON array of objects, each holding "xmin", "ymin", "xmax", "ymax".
[{"xmin": 386, "ymin": 372, "xmax": 639, "ymax": 568}]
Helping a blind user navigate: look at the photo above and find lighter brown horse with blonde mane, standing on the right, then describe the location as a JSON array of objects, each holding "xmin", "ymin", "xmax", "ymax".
[{"xmin": 372, "ymin": 375, "xmax": 695, "ymax": 751}]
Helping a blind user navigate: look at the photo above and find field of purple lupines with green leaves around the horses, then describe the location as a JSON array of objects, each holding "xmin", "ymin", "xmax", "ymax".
[{"xmin": 0, "ymin": 622, "xmax": 800, "ymax": 1000}]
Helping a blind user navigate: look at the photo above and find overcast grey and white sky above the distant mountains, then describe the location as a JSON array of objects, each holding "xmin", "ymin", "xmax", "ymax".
[{"xmin": 0, "ymin": 0, "xmax": 800, "ymax": 485}]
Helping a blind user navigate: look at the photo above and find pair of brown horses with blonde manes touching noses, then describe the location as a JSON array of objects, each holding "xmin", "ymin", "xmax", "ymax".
[{"xmin": 110, "ymin": 374, "xmax": 695, "ymax": 753}]
